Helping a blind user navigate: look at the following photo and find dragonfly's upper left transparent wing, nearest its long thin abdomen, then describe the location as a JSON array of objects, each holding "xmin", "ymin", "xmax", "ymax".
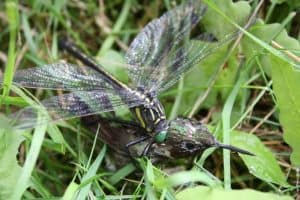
[{"xmin": 9, "ymin": 63, "xmax": 112, "ymax": 91}]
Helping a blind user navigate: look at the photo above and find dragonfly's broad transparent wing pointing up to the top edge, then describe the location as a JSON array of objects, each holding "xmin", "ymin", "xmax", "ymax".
[{"xmin": 125, "ymin": 1, "xmax": 206, "ymax": 90}]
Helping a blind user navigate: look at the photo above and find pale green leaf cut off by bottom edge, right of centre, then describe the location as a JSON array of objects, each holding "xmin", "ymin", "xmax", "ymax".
[{"xmin": 176, "ymin": 186, "xmax": 293, "ymax": 200}]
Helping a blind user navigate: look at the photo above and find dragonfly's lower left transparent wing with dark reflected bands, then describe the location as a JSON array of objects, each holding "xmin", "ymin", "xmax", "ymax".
[{"xmin": 11, "ymin": 90, "xmax": 142, "ymax": 129}]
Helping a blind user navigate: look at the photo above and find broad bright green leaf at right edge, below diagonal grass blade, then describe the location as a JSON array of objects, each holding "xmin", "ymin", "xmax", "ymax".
[{"xmin": 271, "ymin": 57, "xmax": 300, "ymax": 167}]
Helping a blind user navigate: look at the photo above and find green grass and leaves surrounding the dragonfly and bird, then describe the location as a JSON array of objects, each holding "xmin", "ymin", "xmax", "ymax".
[{"xmin": 0, "ymin": 0, "xmax": 300, "ymax": 199}]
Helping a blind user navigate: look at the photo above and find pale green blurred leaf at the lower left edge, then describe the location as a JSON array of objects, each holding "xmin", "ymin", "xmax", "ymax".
[{"xmin": 0, "ymin": 115, "xmax": 24, "ymax": 199}]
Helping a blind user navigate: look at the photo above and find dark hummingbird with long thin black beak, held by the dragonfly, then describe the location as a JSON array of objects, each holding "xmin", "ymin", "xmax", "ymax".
[{"xmin": 83, "ymin": 117, "xmax": 253, "ymax": 164}]
